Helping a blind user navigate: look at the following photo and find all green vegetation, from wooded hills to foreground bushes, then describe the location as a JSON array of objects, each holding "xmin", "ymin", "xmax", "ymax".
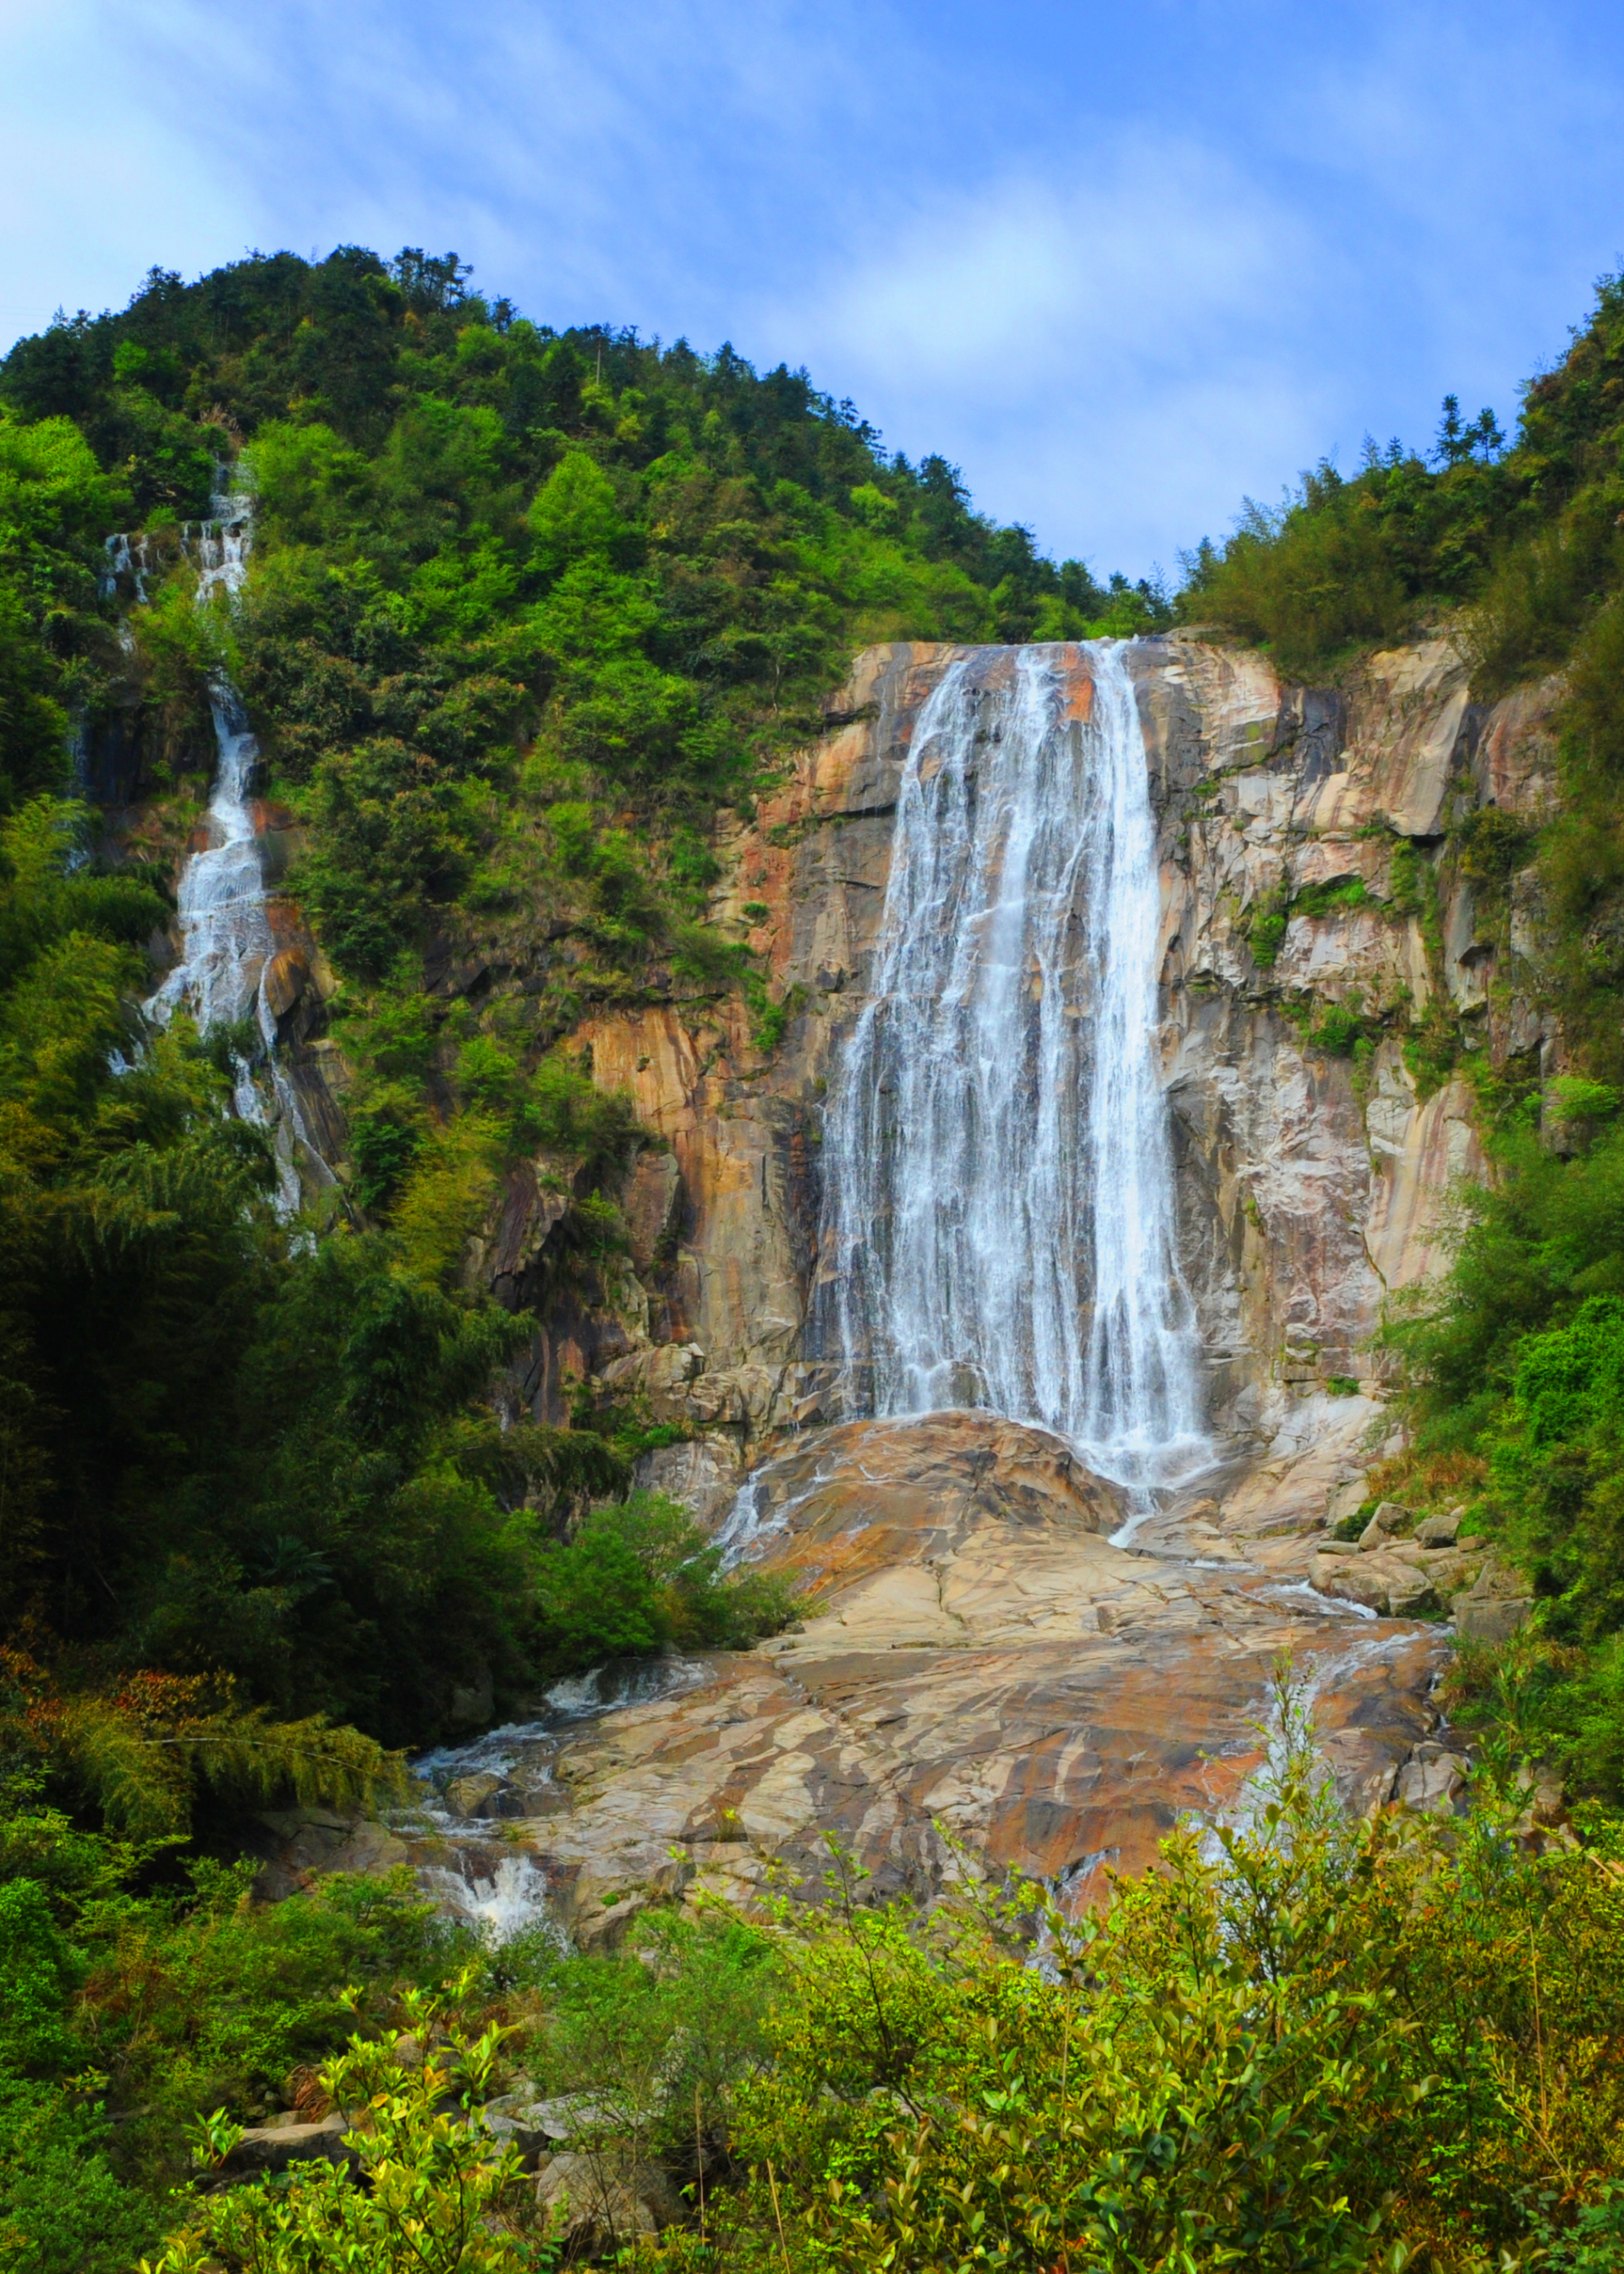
[{"xmin": 0, "ymin": 248, "xmax": 1624, "ymax": 2274}]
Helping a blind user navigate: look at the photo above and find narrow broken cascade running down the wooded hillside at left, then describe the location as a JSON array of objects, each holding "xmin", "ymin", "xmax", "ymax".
[{"xmin": 123, "ymin": 469, "xmax": 334, "ymax": 1217}]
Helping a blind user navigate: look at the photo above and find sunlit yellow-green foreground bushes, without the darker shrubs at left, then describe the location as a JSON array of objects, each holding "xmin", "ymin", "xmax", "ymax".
[{"xmin": 119, "ymin": 1683, "xmax": 1624, "ymax": 2274}]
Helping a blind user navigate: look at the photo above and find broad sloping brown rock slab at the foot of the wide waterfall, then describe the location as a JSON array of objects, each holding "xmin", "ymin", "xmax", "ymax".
[{"xmin": 375, "ymin": 1401, "xmax": 1445, "ymax": 1944}]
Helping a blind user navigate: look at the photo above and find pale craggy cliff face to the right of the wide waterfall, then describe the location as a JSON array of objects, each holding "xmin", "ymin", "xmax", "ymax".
[{"xmin": 1135, "ymin": 639, "xmax": 1554, "ymax": 1425}]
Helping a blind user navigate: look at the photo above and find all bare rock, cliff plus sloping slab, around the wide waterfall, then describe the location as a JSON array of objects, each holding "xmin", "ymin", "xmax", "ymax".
[{"xmin": 307, "ymin": 634, "xmax": 1551, "ymax": 1937}]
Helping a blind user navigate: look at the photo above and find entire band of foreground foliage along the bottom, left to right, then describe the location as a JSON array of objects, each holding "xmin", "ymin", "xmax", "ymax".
[{"xmin": 12, "ymin": 1669, "xmax": 1624, "ymax": 2274}]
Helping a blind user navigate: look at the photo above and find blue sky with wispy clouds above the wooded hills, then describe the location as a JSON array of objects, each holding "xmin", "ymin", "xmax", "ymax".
[{"xmin": 0, "ymin": 0, "xmax": 1624, "ymax": 575}]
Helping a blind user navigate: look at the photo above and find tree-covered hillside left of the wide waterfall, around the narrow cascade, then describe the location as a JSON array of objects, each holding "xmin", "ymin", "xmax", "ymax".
[{"xmin": 0, "ymin": 248, "xmax": 1158, "ymax": 1742}]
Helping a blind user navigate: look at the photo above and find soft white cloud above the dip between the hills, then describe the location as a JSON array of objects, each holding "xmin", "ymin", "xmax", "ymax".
[{"xmin": 760, "ymin": 135, "xmax": 1333, "ymax": 568}]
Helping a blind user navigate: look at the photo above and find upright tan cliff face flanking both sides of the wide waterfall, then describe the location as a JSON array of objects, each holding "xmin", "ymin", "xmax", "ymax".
[{"xmin": 520, "ymin": 637, "xmax": 1554, "ymax": 1514}]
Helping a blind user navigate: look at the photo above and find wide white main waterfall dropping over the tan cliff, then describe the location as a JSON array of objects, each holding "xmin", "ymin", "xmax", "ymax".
[{"xmin": 821, "ymin": 639, "xmax": 1208, "ymax": 1487}]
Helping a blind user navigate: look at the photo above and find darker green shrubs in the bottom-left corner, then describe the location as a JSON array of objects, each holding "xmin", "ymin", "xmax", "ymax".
[{"xmin": 0, "ymin": 1808, "xmax": 459, "ymax": 2274}]
